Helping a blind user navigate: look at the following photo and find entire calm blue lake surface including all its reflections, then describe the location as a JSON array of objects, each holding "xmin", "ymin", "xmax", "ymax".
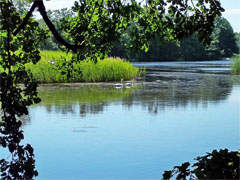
[{"xmin": 23, "ymin": 60, "xmax": 240, "ymax": 179}]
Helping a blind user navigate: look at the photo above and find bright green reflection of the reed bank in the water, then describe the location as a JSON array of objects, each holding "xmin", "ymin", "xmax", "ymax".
[{"xmin": 36, "ymin": 85, "xmax": 130, "ymax": 117}]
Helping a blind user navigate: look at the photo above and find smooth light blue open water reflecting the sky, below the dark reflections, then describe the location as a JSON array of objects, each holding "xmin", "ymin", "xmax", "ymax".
[{"xmin": 24, "ymin": 86, "xmax": 240, "ymax": 179}]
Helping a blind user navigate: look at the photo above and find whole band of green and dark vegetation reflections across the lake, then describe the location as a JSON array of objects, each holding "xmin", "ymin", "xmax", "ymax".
[{"xmin": 36, "ymin": 71, "xmax": 232, "ymax": 117}]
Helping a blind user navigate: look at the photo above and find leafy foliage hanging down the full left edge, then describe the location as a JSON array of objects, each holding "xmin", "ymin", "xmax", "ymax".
[{"xmin": 0, "ymin": 1, "xmax": 45, "ymax": 179}]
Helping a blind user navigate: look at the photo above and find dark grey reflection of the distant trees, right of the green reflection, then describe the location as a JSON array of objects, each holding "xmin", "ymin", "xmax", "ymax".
[{"xmin": 123, "ymin": 74, "xmax": 232, "ymax": 114}]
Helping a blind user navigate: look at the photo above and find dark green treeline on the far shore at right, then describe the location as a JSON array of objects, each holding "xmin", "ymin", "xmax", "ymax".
[{"xmin": 109, "ymin": 17, "xmax": 240, "ymax": 61}]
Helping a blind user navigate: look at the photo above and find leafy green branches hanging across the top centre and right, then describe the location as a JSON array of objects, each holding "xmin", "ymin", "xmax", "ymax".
[{"xmin": 61, "ymin": 0, "xmax": 224, "ymax": 67}]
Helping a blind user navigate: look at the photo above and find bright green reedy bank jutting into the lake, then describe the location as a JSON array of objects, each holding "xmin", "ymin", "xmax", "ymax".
[{"xmin": 26, "ymin": 51, "xmax": 143, "ymax": 83}]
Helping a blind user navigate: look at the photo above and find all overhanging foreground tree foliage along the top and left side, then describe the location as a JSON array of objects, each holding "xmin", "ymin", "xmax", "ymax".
[{"xmin": 0, "ymin": 0, "xmax": 224, "ymax": 179}]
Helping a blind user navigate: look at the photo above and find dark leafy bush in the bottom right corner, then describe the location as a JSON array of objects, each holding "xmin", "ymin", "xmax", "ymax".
[{"xmin": 162, "ymin": 149, "xmax": 240, "ymax": 180}]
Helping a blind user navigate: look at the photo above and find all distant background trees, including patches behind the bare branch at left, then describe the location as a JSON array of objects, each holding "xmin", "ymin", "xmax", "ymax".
[{"xmin": 33, "ymin": 8, "xmax": 240, "ymax": 61}]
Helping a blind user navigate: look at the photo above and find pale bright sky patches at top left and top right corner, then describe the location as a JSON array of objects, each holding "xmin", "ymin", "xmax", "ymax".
[{"xmin": 41, "ymin": 0, "xmax": 240, "ymax": 32}]
